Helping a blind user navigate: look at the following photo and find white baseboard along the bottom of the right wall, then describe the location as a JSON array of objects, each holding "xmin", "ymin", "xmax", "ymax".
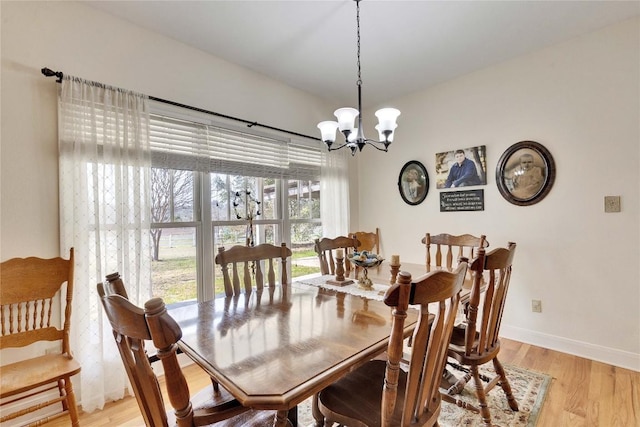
[{"xmin": 500, "ymin": 325, "xmax": 640, "ymax": 372}]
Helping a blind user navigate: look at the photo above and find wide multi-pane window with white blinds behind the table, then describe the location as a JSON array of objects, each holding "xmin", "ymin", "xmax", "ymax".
[{"xmin": 151, "ymin": 105, "xmax": 322, "ymax": 303}]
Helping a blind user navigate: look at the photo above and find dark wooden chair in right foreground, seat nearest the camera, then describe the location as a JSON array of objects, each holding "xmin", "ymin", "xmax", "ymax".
[{"xmin": 317, "ymin": 259, "xmax": 467, "ymax": 427}]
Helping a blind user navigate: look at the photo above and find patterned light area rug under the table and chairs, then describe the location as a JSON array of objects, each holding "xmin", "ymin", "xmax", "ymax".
[{"xmin": 298, "ymin": 364, "xmax": 551, "ymax": 427}]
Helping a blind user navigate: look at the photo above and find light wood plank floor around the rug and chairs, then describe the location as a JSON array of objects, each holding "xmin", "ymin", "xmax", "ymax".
[{"xmin": 45, "ymin": 339, "xmax": 640, "ymax": 427}]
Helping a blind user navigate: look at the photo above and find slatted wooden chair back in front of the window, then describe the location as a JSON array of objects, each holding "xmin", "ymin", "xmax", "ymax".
[{"xmin": 215, "ymin": 243, "xmax": 291, "ymax": 297}]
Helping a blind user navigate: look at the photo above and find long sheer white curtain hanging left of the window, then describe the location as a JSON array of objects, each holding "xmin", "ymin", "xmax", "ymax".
[{"xmin": 58, "ymin": 76, "xmax": 151, "ymax": 411}]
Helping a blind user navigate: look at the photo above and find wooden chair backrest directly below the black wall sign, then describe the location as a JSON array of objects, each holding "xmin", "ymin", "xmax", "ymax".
[{"xmin": 422, "ymin": 233, "xmax": 489, "ymax": 271}]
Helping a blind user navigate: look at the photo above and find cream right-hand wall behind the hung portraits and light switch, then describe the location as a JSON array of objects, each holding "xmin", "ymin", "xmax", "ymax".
[{"xmin": 359, "ymin": 19, "xmax": 640, "ymax": 370}]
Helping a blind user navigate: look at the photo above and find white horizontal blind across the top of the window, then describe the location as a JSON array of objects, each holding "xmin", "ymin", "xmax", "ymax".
[{"xmin": 150, "ymin": 104, "xmax": 321, "ymax": 180}]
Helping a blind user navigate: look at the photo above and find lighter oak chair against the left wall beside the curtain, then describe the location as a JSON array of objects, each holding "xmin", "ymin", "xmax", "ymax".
[{"xmin": 0, "ymin": 248, "xmax": 80, "ymax": 427}]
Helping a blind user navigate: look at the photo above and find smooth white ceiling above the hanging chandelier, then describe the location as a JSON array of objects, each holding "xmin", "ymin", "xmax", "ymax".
[{"xmin": 83, "ymin": 0, "xmax": 640, "ymax": 108}]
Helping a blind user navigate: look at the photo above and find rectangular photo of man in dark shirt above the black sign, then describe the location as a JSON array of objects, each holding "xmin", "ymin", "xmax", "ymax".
[{"xmin": 436, "ymin": 145, "xmax": 487, "ymax": 189}]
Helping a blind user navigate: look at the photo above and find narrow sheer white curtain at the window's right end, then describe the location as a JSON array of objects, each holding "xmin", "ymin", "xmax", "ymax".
[{"xmin": 320, "ymin": 150, "xmax": 351, "ymax": 238}]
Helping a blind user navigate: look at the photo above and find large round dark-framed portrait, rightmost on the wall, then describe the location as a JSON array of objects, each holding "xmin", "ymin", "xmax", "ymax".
[{"xmin": 496, "ymin": 141, "xmax": 556, "ymax": 206}]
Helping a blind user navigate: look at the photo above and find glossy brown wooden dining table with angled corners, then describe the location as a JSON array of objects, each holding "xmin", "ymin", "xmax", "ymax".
[{"xmin": 169, "ymin": 282, "xmax": 417, "ymax": 427}]
